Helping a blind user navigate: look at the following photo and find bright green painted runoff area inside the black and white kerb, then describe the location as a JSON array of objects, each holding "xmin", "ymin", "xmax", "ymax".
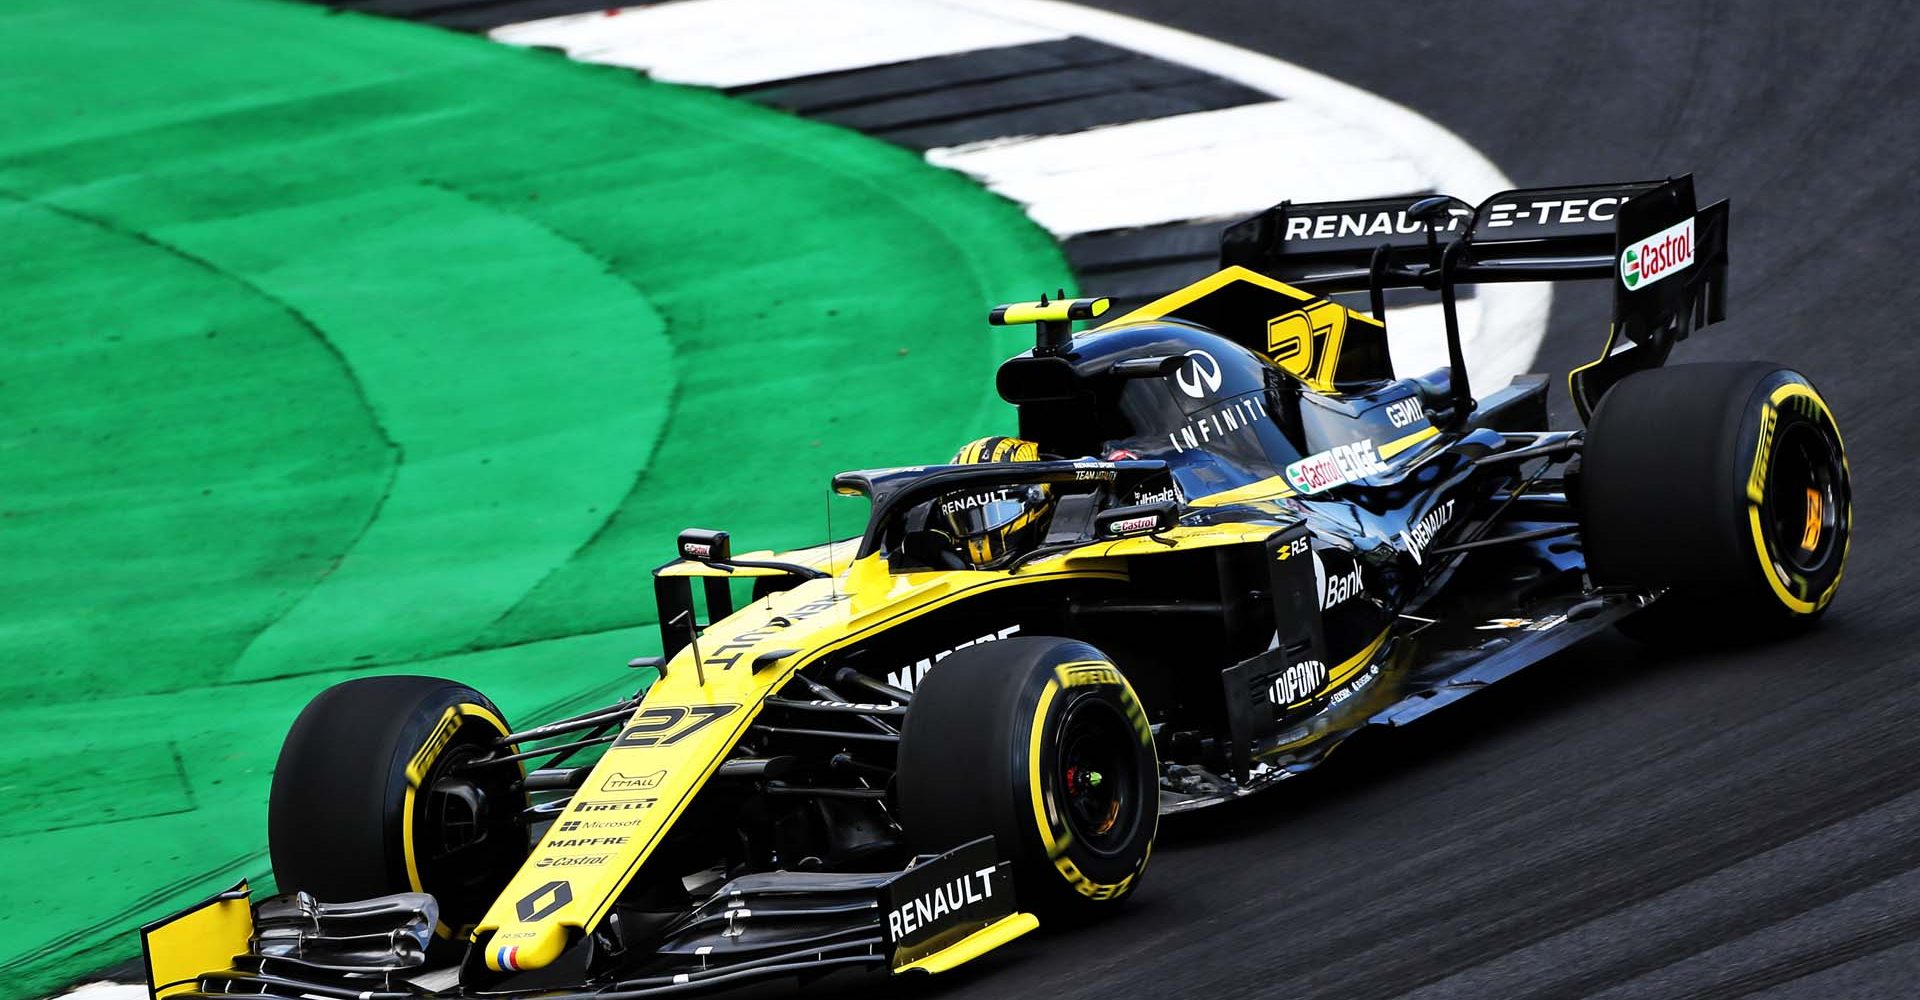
[{"xmin": 0, "ymin": 0, "xmax": 1071, "ymax": 998}]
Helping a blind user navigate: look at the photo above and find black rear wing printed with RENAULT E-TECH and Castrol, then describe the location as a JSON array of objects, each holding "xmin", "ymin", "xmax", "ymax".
[{"xmin": 1221, "ymin": 175, "xmax": 1728, "ymax": 420}]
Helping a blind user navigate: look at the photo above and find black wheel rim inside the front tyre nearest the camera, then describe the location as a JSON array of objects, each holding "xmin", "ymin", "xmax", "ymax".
[{"xmin": 1054, "ymin": 699, "xmax": 1140, "ymax": 856}]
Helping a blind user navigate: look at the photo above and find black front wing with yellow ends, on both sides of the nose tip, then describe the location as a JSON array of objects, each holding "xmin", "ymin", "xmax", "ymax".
[{"xmin": 142, "ymin": 837, "xmax": 1039, "ymax": 1000}]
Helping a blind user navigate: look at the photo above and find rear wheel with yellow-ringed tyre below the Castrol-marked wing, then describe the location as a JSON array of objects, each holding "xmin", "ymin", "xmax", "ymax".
[{"xmin": 1578, "ymin": 363, "xmax": 1853, "ymax": 643}]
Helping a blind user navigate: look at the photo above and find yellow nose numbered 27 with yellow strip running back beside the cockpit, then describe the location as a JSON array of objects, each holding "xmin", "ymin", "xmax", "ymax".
[{"xmin": 476, "ymin": 524, "xmax": 1297, "ymax": 971}]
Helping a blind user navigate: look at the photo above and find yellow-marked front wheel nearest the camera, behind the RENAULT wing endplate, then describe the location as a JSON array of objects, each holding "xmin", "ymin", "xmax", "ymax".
[{"xmin": 897, "ymin": 637, "xmax": 1160, "ymax": 921}]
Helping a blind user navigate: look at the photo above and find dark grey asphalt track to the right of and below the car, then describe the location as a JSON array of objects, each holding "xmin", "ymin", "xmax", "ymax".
[{"xmin": 890, "ymin": 0, "xmax": 1920, "ymax": 1000}]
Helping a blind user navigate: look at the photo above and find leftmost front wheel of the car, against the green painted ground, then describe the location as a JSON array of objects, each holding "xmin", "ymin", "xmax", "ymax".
[{"xmin": 267, "ymin": 678, "xmax": 528, "ymax": 960}]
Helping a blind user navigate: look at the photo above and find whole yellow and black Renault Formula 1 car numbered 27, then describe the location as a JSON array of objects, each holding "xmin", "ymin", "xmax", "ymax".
[{"xmin": 146, "ymin": 179, "xmax": 1851, "ymax": 1000}]
